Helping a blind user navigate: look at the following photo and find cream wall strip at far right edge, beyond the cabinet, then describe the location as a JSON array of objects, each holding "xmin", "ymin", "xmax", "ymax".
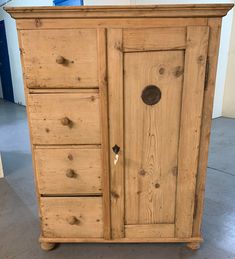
[{"xmin": 222, "ymin": 6, "xmax": 235, "ymax": 118}]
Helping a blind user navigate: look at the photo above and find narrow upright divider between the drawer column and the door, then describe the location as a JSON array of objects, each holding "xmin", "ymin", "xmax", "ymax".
[{"xmin": 97, "ymin": 28, "xmax": 111, "ymax": 239}]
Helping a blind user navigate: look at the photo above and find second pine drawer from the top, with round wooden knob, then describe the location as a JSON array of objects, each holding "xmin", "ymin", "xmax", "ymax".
[{"xmin": 28, "ymin": 93, "xmax": 100, "ymax": 144}]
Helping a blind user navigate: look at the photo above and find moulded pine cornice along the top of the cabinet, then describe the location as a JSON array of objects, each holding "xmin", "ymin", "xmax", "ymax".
[{"xmin": 5, "ymin": 4, "xmax": 234, "ymax": 19}]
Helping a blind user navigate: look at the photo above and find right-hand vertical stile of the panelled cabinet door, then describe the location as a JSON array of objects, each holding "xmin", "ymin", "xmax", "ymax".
[{"xmin": 175, "ymin": 26, "xmax": 209, "ymax": 238}]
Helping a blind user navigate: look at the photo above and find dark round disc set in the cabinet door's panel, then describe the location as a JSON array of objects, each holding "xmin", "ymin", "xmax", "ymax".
[{"xmin": 141, "ymin": 85, "xmax": 161, "ymax": 105}]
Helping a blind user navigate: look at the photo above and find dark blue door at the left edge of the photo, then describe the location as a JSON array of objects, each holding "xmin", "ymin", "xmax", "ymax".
[{"xmin": 0, "ymin": 21, "xmax": 14, "ymax": 102}]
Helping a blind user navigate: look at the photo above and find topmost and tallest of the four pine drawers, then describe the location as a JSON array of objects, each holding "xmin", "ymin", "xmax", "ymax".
[{"xmin": 20, "ymin": 29, "xmax": 98, "ymax": 88}]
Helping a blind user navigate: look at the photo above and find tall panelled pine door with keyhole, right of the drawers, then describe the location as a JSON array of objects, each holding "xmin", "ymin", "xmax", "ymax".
[{"xmin": 107, "ymin": 26, "xmax": 209, "ymax": 239}]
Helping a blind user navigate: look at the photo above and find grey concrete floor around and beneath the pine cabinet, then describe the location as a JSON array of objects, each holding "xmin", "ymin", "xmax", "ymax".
[{"xmin": 0, "ymin": 100, "xmax": 235, "ymax": 259}]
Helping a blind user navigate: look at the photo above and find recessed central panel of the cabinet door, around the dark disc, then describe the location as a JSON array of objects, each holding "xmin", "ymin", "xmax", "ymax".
[{"xmin": 124, "ymin": 51, "xmax": 184, "ymax": 224}]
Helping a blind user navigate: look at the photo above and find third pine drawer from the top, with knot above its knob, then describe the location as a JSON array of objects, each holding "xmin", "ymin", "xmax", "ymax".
[{"xmin": 34, "ymin": 148, "xmax": 101, "ymax": 194}]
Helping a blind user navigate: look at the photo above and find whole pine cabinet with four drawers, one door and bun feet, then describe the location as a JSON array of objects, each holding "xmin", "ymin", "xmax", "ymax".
[{"xmin": 7, "ymin": 4, "xmax": 233, "ymax": 250}]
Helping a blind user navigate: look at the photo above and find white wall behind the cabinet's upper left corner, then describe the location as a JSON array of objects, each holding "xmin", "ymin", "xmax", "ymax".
[{"xmin": 0, "ymin": 0, "xmax": 53, "ymax": 105}]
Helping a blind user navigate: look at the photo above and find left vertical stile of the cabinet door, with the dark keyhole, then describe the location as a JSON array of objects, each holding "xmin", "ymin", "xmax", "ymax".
[{"xmin": 108, "ymin": 29, "xmax": 124, "ymax": 238}]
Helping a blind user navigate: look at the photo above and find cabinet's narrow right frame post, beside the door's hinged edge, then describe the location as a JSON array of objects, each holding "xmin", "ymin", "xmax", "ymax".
[{"xmin": 193, "ymin": 18, "xmax": 221, "ymax": 236}]
